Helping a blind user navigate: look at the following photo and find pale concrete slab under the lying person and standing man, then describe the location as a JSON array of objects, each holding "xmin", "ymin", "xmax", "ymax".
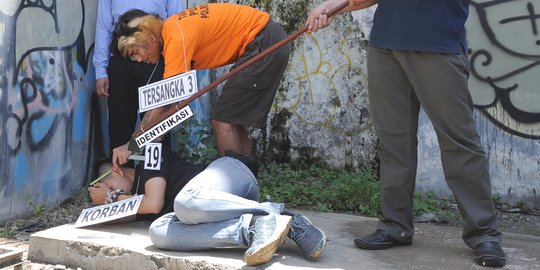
[{"xmin": 28, "ymin": 212, "xmax": 540, "ymax": 270}]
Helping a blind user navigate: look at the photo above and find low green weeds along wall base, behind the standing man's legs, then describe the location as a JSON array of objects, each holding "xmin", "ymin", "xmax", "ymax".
[{"xmin": 258, "ymin": 162, "xmax": 446, "ymax": 217}]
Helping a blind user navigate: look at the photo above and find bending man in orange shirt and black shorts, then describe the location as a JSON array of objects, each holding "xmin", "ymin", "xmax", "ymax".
[{"xmin": 113, "ymin": 3, "xmax": 291, "ymax": 162}]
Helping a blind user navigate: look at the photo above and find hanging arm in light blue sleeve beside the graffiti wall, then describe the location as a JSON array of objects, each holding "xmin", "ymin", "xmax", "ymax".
[{"xmin": 92, "ymin": 0, "xmax": 113, "ymax": 96}]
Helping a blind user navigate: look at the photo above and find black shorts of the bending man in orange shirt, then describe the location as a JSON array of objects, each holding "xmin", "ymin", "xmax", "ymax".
[{"xmin": 212, "ymin": 20, "xmax": 291, "ymax": 128}]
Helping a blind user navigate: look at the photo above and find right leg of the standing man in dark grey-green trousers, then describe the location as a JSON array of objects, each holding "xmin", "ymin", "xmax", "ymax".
[{"xmin": 400, "ymin": 51, "xmax": 506, "ymax": 266}]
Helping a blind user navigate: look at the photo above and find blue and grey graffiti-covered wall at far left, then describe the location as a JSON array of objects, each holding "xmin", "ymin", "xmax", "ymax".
[{"xmin": 0, "ymin": 0, "xmax": 99, "ymax": 224}]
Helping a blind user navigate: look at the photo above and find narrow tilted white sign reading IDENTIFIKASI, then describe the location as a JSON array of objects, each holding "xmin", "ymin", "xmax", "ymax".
[{"xmin": 135, "ymin": 106, "xmax": 193, "ymax": 149}]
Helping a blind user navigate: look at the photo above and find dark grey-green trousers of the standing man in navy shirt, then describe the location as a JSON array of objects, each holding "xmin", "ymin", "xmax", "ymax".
[{"xmin": 368, "ymin": 47, "xmax": 501, "ymax": 248}]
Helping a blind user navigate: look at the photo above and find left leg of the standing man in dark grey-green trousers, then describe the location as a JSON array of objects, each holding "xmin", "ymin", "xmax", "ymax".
[{"xmin": 357, "ymin": 47, "xmax": 420, "ymax": 245}]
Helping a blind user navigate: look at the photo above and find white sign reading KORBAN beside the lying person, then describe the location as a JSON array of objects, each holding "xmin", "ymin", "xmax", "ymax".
[{"xmin": 75, "ymin": 195, "xmax": 143, "ymax": 228}]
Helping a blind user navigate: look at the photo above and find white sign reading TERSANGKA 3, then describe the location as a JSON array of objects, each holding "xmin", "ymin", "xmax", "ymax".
[{"xmin": 139, "ymin": 70, "xmax": 199, "ymax": 112}]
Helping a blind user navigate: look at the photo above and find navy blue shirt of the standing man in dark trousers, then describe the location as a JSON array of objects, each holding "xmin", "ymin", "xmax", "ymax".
[{"xmin": 370, "ymin": 0, "xmax": 470, "ymax": 53}]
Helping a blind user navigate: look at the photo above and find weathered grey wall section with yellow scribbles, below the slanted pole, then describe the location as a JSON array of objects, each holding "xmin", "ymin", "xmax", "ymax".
[{"xmin": 259, "ymin": 10, "xmax": 375, "ymax": 168}]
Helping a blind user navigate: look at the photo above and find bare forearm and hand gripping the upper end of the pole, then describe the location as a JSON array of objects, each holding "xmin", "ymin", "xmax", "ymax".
[{"xmin": 306, "ymin": 0, "xmax": 377, "ymax": 33}]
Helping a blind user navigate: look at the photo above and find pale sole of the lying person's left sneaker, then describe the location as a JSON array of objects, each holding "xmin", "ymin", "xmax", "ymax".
[{"xmin": 244, "ymin": 216, "xmax": 292, "ymax": 265}]
